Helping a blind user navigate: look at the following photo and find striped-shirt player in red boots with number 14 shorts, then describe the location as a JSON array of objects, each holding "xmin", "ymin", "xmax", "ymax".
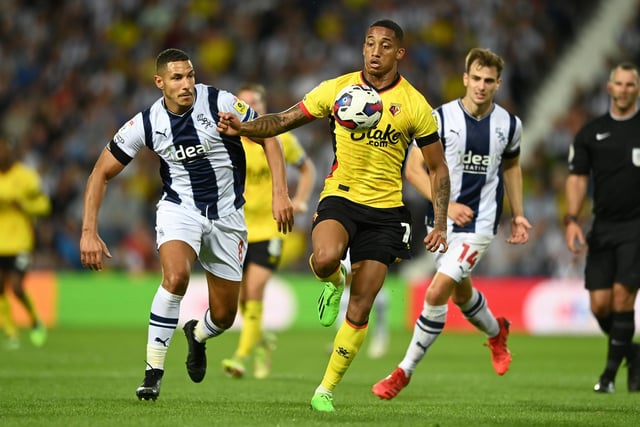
[{"xmin": 372, "ymin": 48, "xmax": 531, "ymax": 399}]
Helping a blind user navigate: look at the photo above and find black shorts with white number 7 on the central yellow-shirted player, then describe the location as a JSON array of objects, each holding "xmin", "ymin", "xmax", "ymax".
[{"xmin": 313, "ymin": 196, "xmax": 412, "ymax": 265}]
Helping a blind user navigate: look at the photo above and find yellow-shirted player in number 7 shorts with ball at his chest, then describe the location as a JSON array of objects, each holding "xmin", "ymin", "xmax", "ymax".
[{"xmin": 218, "ymin": 19, "xmax": 449, "ymax": 412}]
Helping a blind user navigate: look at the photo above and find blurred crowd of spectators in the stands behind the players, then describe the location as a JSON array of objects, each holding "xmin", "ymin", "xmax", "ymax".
[{"xmin": 0, "ymin": 0, "xmax": 640, "ymax": 276}]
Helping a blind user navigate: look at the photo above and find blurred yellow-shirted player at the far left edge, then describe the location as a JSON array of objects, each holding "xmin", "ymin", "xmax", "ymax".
[{"xmin": 0, "ymin": 132, "xmax": 51, "ymax": 349}]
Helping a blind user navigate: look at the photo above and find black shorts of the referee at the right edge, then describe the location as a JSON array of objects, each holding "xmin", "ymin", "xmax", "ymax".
[{"xmin": 585, "ymin": 220, "xmax": 640, "ymax": 290}]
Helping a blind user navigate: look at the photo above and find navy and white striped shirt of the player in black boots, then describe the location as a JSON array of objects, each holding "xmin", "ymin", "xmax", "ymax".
[{"xmin": 108, "ymin": 84, "xmax": 257, "ymax": 219}]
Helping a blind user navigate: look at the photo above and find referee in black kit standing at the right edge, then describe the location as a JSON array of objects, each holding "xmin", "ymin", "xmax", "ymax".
[{"xmin": 564, "ymin": 62, "xmax": 640, "ymax": 393}]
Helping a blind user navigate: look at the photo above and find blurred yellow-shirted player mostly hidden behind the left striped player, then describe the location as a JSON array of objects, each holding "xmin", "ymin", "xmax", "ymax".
[{"xmin": 222, "ymin": 83, "xmax": 316, "ymax": 379}]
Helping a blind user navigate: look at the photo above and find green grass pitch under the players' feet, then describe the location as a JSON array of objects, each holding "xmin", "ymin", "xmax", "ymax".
[{"xmin": 0, "ymin": 328, "xmax": 640, "ymax": 427}]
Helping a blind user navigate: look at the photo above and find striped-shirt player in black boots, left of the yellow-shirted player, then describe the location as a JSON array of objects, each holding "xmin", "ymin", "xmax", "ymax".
[{"xmin": 80, "ymin": 49, "xmax": 293, "ymax": 400}]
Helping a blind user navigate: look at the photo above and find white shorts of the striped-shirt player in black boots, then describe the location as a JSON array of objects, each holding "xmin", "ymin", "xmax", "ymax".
[{"xmin": 156, "ymin": 200, "xmax": 247, "ymax": 282}]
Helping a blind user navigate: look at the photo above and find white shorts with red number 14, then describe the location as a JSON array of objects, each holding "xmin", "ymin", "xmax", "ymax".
[{"xmin": 434, "ymin": 230, "xmax": 494, "ymax": 283}]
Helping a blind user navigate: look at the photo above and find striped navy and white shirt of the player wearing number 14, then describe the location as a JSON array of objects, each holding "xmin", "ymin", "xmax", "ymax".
[{"xmin": 427, "ymin": 99, "xmax": 522, "ymax": 235}]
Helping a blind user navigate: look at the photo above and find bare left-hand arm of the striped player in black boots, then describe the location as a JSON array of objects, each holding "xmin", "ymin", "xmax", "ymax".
[{"xmin": 80, "ymin": 148, "xmax": 124, "ymax": 271}]
